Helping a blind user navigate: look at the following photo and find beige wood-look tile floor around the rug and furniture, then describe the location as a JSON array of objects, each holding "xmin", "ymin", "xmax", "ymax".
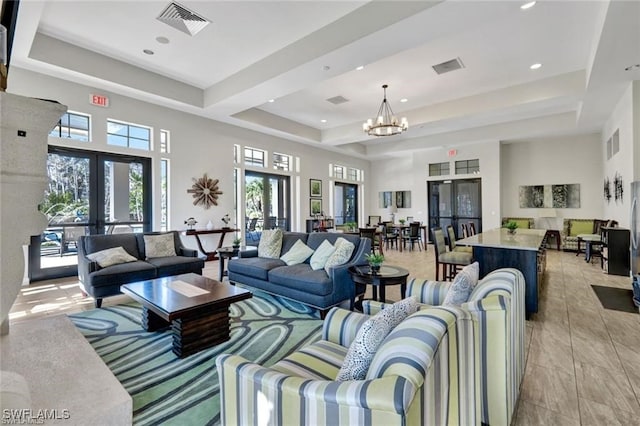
[{"xmin": 10, "ymin": 247, "xmax": 640, "ymax": 426}]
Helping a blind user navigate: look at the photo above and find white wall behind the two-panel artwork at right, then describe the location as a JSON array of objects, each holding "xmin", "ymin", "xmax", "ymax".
[{"xmin": 500, "ymin": 134, "xmax": 604, "ymax": 229}]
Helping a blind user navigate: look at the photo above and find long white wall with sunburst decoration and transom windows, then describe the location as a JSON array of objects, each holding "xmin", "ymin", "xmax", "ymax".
[{"xmin": 8, "ymin": 67, "xmax": 369, "ymax": 243}]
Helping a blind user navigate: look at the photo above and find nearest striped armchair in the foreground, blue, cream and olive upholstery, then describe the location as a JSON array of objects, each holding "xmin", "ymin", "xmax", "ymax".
[{"xmin": 216, "ymin": 308, "xmax": 480, "ymax": 426}]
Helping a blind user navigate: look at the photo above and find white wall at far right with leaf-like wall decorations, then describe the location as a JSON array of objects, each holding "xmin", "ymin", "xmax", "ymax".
[{"xmin": 601, "ymin": 85, "xmax": 639, "ymax": 228}]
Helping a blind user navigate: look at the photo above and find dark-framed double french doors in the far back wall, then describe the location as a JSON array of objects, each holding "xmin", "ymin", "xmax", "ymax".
[{"xmin": 427, "ymin": 179, "xmax": 482, "ymax": 243}]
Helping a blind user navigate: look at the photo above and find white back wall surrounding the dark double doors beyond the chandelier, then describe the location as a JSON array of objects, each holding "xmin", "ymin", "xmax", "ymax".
[{"xmin": 369, "ymin": 141, "xmax": 500, "ymax": 229}]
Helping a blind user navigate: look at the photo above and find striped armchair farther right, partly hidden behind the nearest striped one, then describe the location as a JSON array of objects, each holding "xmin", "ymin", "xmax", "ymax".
[{"xmin": 363, "ymin": 268, "xmax": 525, "ymax": 426}]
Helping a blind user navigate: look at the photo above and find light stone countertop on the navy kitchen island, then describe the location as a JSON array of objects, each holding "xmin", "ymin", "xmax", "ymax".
[{"xmin": 456, "ymin": 228, "xmax": 546, "ymax": 251}]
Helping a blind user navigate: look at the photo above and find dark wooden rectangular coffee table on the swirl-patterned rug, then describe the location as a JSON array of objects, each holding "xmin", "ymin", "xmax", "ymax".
[{"xmin": 121, "ymin": 274, "xmax": 253, "ymax": 358}]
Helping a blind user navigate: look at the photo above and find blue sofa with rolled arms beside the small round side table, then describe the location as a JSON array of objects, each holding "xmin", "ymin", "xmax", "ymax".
[{"xmin": 227, "ymin": 232, "xmax": 371, "ymax": 318}]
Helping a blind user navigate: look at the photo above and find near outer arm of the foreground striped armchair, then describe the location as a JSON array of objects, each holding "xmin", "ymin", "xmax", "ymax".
[{"xmin": 216, "ymin": 354, "xmax": 416, "ymax": 424}]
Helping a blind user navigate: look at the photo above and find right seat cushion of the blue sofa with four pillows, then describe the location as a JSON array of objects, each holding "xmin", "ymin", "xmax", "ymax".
[{"xmin": 269, "ymin": 263, "xmax": 334, "ymax": 296}]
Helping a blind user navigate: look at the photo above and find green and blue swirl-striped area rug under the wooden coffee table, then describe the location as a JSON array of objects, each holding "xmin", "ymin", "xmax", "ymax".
[{"xmin": 69, "ymin": 292, "xmax": 322, "ymax": 425}]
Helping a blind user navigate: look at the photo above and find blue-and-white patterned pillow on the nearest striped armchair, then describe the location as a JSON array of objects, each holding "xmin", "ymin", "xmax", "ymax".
[{"xmin": 336, "ymin": 311, "xmax": 391, "ymax": 381}]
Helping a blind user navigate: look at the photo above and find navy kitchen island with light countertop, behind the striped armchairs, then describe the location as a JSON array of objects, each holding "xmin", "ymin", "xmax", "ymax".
[{"xmin": 456, "ymin": 228, "xmax": 546, "ymax": 319}]
